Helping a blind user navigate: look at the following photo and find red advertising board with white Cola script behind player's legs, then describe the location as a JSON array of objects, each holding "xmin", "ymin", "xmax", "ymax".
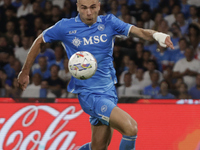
[{"xmin": 0, "ymin": 103, "xmax": 200, "ymax": 150}]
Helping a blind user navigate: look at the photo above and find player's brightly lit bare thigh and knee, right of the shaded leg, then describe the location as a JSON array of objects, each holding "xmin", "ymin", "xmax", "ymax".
[{"xmin": 110, "ymin": 107, "xmax": 138, "ymax": 136}]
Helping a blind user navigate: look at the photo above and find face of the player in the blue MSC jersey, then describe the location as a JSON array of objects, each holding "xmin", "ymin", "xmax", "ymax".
[{"xmin": 77, "ymin": 0, "xmax": 100, "ymax": 26}]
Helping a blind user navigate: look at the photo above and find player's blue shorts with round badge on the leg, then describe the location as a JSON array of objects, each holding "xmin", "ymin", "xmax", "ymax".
[{"xmin": 78, "ymin": 86, "xmax": 118, "ymax": 125}]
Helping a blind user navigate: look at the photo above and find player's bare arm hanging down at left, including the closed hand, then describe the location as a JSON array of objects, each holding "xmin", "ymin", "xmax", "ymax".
[{"xmin": 17, "ymin": 34, "xmax": 44, "ymax": 90}]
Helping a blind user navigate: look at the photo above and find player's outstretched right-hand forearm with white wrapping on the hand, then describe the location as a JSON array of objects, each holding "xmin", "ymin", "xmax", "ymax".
[{"xmin": 129, "ymin": 26, "xmax": 174, "ymax": 49}]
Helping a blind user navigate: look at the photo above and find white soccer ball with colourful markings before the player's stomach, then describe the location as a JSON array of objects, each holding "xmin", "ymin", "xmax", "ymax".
[{"xmin": 68, "ymin": 51, "xmax": 97, "ymax": 80}]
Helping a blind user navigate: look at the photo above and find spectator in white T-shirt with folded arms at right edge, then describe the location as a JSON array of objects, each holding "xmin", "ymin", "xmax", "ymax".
[{"xmin": 173, "ymin": 48, "xmax": 200, "ymax": 89}]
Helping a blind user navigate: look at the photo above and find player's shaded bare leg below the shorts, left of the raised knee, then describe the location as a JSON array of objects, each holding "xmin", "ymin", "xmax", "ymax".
[{"xmin": 91, "ymin": 122, "xmax": 113, "ymax": 150}]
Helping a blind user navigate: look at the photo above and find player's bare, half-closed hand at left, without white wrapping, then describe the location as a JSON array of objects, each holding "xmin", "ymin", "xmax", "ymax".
[{"xmin": 17, "ymin": 71, "xmax": 29, "ymax": 91}]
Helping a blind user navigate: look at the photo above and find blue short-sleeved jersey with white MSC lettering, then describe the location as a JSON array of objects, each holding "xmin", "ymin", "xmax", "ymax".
[{"xmin": 43, "ymin": 14, "xmax": 132, "ymax": 93}]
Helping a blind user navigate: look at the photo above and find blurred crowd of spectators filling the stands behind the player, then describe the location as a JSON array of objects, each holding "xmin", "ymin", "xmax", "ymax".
[{"xmin": 0, "ymin": 0, "xmax": 200, "ymax": 99}]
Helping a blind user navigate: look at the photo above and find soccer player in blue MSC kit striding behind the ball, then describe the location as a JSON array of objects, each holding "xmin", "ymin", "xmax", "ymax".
[{"xmin": 18, "ymin": 0, "xmax": 173, "ymax": 150}]
